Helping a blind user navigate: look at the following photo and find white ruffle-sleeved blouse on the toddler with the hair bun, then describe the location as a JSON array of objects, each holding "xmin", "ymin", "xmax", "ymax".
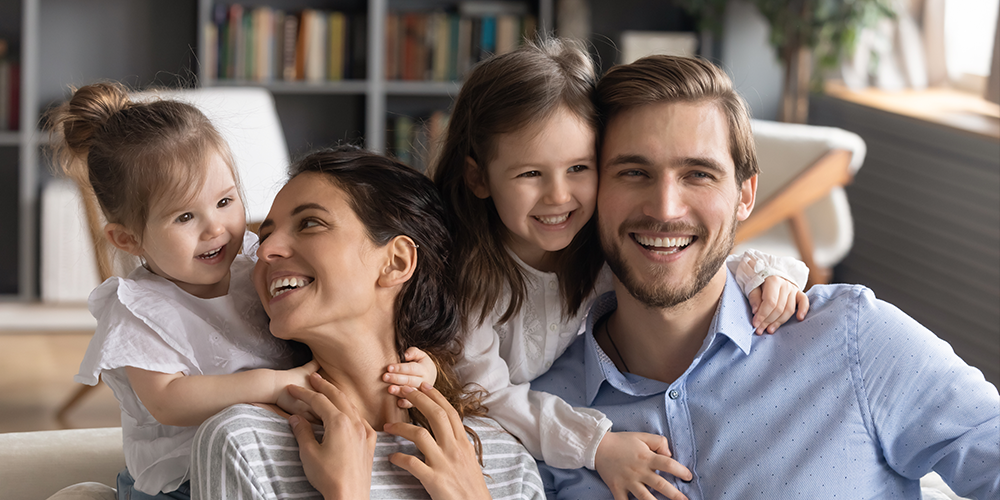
[{"xmin": 73, "ymin": 233, "xmax": 296, "ymax": 494}]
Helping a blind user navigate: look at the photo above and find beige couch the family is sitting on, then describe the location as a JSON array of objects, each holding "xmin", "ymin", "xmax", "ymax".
[{"xmin": 0, "ymin": 427, "xmax": 961, "ymax": 500}]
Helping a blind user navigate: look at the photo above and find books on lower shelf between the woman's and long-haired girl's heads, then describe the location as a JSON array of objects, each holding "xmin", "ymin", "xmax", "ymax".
[{"xmin": 386, "ymin": 111, "xmax": 449, "ymax": 172}]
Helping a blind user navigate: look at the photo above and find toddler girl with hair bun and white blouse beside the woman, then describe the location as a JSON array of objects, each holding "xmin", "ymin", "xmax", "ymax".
[{"xmin": 51, "ymin": 83, "xmax": 435, "ymax": 499}]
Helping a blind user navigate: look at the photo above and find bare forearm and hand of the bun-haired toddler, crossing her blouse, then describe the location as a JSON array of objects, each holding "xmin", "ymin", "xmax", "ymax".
[{"xmin": 125, "ymin": 360, "xmax": 319, "ymax": 426}]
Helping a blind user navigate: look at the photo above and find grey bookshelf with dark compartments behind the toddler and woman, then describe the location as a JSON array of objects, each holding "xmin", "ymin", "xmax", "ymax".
[{"xmin": 0, "ymin": 0, "xmax": 554, "ymax": 301}]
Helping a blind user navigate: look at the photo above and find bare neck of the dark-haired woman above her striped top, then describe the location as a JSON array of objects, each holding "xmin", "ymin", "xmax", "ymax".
[{"xmin": 308, "ymin": 328, "xmax": 409, "ymax": 431}]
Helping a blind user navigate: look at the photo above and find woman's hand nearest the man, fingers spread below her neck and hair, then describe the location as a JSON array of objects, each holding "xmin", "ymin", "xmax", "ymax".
[{"xmin": 385, "ymin": 382, "xmax": 491, "ymax": 500}]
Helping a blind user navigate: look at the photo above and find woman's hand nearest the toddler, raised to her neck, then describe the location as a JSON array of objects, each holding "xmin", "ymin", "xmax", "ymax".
[{"xmin": 288, "ymin": 373, "xmax": 377, "ymax": 498}]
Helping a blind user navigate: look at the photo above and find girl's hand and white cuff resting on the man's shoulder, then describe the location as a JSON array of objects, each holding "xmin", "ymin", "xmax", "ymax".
[{"xmin": 726, "ymin": 249, "xmax": 809, "ymax": 335}]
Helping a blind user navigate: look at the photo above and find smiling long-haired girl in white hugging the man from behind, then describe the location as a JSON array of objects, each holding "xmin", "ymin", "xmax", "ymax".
[{"xmin": 385, "ymin": 39, "xmax": 808, "ymax": 499}]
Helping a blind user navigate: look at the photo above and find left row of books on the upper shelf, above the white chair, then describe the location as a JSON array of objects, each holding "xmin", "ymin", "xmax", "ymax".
[{"xmin": 204, "ymin": 4, "xmax": 368, "ymax": 82}]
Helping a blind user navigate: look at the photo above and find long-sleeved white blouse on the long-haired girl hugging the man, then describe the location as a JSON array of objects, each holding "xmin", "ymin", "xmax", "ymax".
[{"xmin": 455, "ymin": 250, "xmax": 809, "ymax": 469}]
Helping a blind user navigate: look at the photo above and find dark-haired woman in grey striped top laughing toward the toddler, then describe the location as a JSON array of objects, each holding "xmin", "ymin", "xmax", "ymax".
[{"xmin": 192, "ymin": 147, "xmax": 542, "ymax": 498}]
